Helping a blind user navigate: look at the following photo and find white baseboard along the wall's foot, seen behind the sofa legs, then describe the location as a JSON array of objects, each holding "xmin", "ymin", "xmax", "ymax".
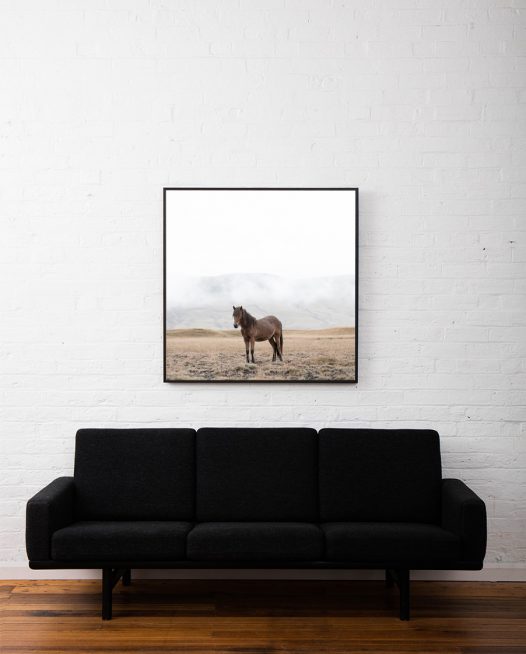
[{"xmin": 0, "ymin": 564, "xmax": 526, "ymax": 581}]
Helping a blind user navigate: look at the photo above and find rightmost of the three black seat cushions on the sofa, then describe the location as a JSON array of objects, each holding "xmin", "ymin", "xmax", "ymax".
[{"xmin": 321, "ymin": 522, "xmax": 460, "ymax": 566}]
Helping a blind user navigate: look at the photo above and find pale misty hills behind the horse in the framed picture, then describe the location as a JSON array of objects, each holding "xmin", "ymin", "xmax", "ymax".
[{"xmin": 166, "ymin": 274, "xmax": 354, "ymax": 329}]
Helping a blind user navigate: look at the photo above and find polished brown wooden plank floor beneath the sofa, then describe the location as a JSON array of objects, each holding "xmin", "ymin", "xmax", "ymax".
[{"xmin": 0, "ymin": 580, "xmax": 526, "ymax": 654}]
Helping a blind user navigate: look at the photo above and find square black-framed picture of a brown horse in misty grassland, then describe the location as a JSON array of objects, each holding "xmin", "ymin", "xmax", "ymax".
[{"xmin": 163, "ymin": 188, "xmax": 358, "ymax": 383}]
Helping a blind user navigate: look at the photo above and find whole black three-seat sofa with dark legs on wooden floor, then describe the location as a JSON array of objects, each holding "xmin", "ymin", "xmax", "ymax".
[{"xmin": 26, "ymin": 428, "xmax": 486, "ymax": 620}]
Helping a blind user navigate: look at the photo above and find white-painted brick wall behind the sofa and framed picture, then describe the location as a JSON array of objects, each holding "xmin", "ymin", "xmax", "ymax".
[{"xmin": 0, "ymin": 0, "xmax": 526, "ymax": 578}]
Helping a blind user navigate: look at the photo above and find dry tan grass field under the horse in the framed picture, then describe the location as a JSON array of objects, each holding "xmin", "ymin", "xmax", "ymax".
[{"xmin": 166, "ymin": 327, "xmax": 355, "ymax": 381}]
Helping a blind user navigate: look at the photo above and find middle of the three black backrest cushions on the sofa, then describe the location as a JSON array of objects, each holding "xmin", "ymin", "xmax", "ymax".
[{"xmin": 196, "ymin": 428, "xmax": 318, "ymax": 522}]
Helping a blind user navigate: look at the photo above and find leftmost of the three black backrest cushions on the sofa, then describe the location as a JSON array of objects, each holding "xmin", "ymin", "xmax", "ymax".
[{"xmin": 75, "ymin": 429, "xmax": 195, "ymax": 520}]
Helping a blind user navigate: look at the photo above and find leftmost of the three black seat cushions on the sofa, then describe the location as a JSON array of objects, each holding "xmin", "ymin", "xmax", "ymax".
[{"xmin": 51, "ymin": 521, "xmax": 192, "ymax": 561}]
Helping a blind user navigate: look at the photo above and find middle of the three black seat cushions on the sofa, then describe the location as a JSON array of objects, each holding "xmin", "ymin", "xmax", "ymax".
[{"xmin": 187, "ymin": 522, "xmax": 323, "ymax": 561}]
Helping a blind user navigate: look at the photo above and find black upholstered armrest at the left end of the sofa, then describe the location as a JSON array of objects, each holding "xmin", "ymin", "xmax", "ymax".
[{"xmin": 26, "ymin": 477, "xmax": 75, "ymax": 561}]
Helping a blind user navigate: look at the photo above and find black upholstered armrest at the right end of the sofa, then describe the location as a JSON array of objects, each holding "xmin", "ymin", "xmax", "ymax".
[{"xmin": 442, "ymin": 479, "xmax": 487, "ymax": 567}]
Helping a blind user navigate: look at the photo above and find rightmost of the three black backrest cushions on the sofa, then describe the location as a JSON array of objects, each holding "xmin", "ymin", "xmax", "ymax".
[{"xmin": 319, "ymin": 429, "xmax": 442, "ymax": 523}]
